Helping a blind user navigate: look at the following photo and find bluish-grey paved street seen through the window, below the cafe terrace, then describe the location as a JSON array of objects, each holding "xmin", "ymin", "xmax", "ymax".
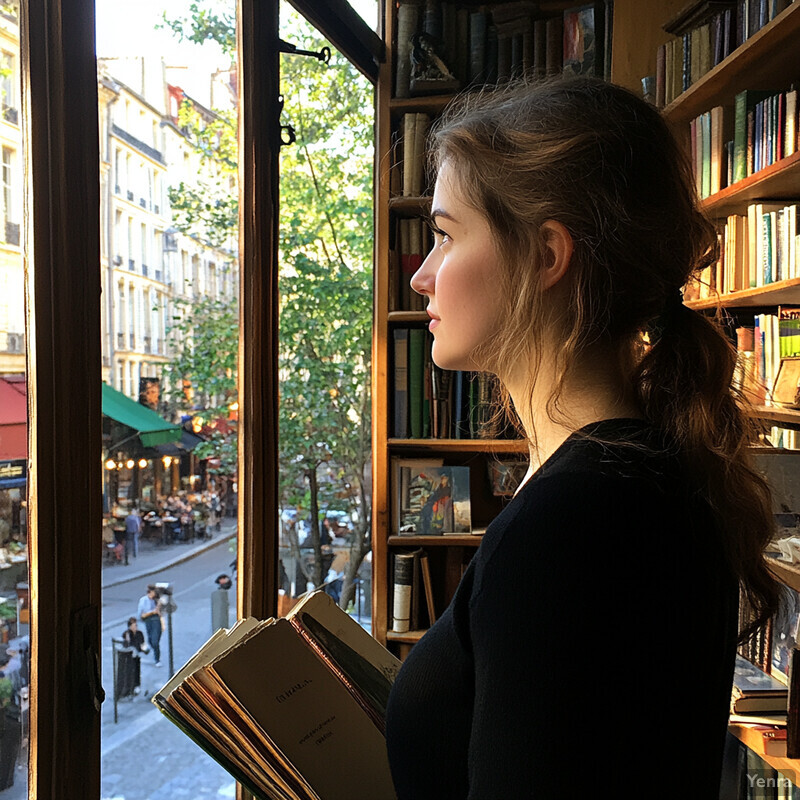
[{"xmin": 101, "ymin": 539, "xmax": 236, "ymax": 800}]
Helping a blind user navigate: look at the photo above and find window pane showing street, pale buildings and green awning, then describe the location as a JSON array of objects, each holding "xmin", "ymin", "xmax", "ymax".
[{"xmin": 96, "ymin": 0, "xmax": 239, "ymax": 800}]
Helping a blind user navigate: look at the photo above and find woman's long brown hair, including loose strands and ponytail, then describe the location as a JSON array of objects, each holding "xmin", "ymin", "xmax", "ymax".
[{"xmin": 431, "ymin": 78, "xmax": 777, "ymax": 640}]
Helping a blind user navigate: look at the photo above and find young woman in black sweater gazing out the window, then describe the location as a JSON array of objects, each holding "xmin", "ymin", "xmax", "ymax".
[{"xmin": 387, "ymin": 79, "xmax": 776, "ymax": 800}]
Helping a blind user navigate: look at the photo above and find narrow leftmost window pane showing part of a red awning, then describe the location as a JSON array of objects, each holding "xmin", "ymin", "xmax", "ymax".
[{"xmin": 0, "ymin": 4, "xmax": 30, "ymax": 800}]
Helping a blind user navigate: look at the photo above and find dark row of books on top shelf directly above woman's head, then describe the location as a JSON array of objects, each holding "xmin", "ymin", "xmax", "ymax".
[{"xmin": 395, "ymin": 0, "xmax": 613, "ymax": 97}]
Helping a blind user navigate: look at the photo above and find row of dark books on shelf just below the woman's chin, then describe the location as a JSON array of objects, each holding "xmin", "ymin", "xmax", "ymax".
[{"xmin": 392, "ymin": 327, "xmax": 510, "ymax": 439}]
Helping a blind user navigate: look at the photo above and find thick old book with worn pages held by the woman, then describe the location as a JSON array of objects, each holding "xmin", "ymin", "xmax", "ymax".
[{"xmin": 153, "ymin": 592, "xmax": 400, "ymax": 800}]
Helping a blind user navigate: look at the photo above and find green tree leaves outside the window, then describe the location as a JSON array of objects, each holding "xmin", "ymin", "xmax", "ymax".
[{"xmin": 168, "ymin": 2, "xmax": 374, "ymax": 588}]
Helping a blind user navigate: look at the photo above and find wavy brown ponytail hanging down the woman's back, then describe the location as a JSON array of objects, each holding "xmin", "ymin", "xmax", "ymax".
[{"xmin": 634, "ymin": 304, "xmax": 778, "ymax": 642}]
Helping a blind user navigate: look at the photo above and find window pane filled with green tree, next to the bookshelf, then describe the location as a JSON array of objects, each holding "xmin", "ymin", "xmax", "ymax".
[{"xmin": 279, "ymin": 3, "xmax": 373, "ymax": 627}]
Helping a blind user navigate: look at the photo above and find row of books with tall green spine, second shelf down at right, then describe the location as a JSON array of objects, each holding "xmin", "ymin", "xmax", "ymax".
[{"xmin": 689, "ymin": 87, "xmax": 798, "ymax": 197}]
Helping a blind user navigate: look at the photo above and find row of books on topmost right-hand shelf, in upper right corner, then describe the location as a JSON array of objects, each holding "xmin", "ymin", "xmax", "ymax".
[{"xmin": 656, "ymin": 0, "xmax": 791, "ymax": 107}]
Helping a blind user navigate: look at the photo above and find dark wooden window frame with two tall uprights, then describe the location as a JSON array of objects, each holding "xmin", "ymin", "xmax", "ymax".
[{"xmin": 20, "ymin": 0, "xmax": 382, "ymax": 800}]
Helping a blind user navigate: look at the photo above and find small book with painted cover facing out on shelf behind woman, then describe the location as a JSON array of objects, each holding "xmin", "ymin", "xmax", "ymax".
[{"xmin": 399, "ymin": 466, "xmax": 472, "ymax": 536}]
